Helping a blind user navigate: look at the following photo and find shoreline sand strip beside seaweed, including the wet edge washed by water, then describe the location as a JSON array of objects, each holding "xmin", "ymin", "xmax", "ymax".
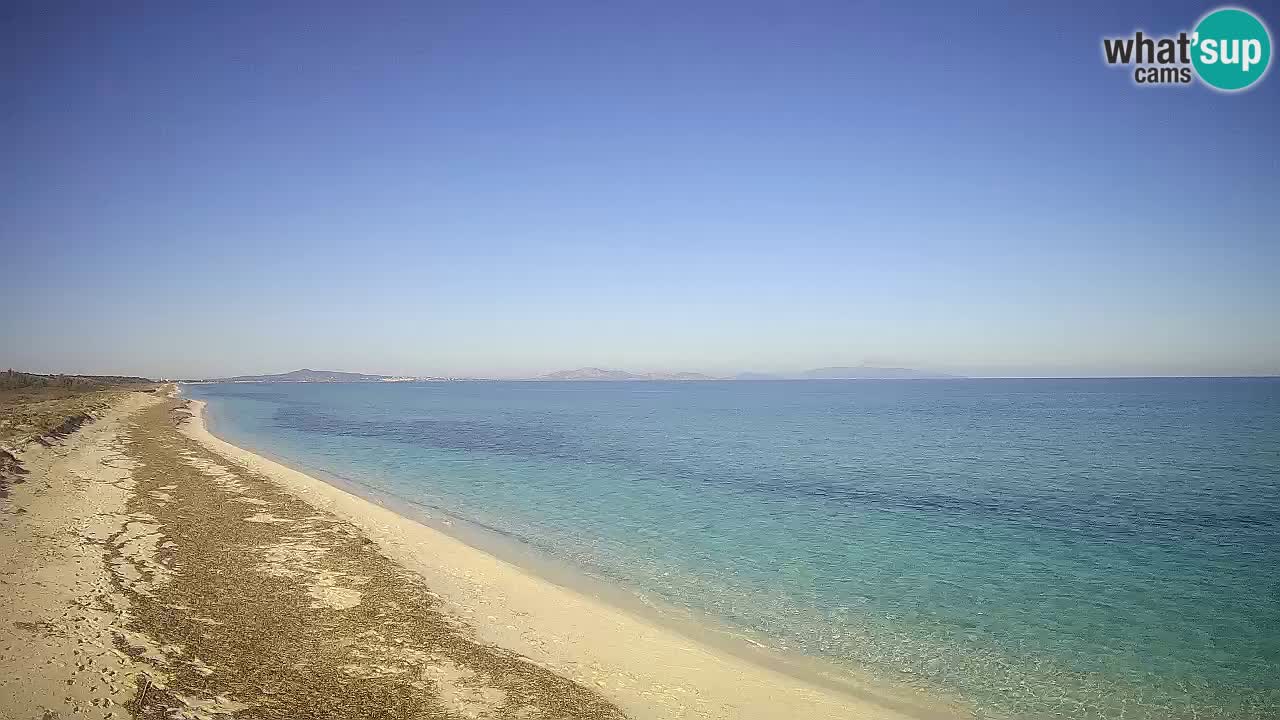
[{"xmin": 180, "ymin": 392, "xmax": 969, "ymax": 720}]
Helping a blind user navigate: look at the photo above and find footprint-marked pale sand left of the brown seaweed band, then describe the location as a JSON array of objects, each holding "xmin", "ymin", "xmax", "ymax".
[{"xmin": 0, "ymin": 393, "xmax": 164, "ymax": 720}]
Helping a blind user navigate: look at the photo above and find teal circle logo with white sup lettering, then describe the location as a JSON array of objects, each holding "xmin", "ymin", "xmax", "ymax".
[{"xmin": 1192, "ymin": 8, "xmax": 1271, "ymax": 92}]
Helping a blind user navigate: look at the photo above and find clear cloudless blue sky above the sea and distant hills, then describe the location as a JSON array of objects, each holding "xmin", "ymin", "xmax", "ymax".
[{"xmin": 0, "ymin": 0, "xmax": 1280, "ymax": 378}]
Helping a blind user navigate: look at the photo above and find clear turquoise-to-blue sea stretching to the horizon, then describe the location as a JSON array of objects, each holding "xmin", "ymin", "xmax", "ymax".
[{"xmin": 184, "ymin": 379, "xmax": 1280, "ymax": 720}]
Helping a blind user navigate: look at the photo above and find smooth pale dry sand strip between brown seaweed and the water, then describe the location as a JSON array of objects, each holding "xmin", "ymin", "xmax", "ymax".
[{"xmin": 183, "ymin": 402, "xmax": 942, "ymax": 720}]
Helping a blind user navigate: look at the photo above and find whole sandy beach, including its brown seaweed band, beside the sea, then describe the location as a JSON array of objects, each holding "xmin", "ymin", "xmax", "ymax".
[{"xmin": 0, "ymin": 391, "xmax": 941, "ymax": 719}]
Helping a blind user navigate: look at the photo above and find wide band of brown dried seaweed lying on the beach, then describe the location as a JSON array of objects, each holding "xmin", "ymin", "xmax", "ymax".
[{"xmin": 113, "ymin": 402, "xmax": 623, "ymax": 719}]
